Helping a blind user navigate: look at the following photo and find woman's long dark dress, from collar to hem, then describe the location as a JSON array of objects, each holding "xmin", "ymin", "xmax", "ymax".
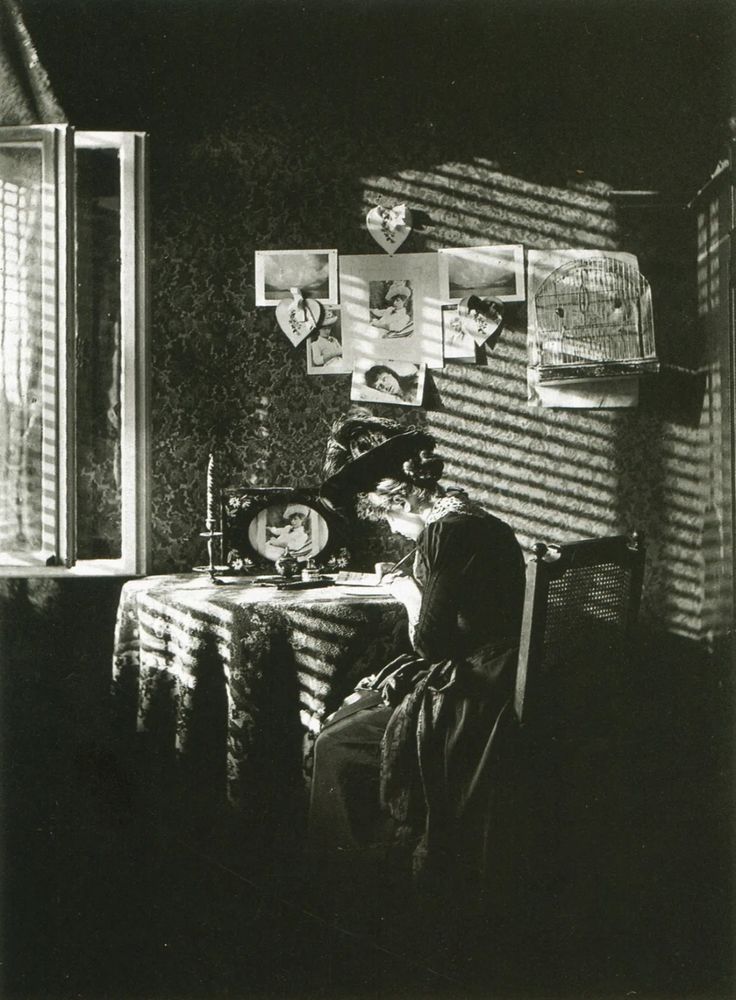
[{"xmin": 310, "ymin": 503, "xmax": 524, "ymax": 896}]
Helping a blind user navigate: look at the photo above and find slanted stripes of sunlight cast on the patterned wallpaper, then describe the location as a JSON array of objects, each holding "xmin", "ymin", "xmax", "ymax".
[{"xmin": 363, "ymin": 158, "xmax": 712, "ymax": 637}]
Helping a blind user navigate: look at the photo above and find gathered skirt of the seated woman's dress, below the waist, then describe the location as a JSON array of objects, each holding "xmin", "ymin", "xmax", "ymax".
[{"xmin": 310, "ymin": 642, "xmax": 518, "ymax": 892}]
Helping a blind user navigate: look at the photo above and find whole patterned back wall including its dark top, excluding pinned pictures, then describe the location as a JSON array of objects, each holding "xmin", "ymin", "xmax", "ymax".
[{"xmin": 0, "ymin": 3, "xmax": 728, "ymax": 637}]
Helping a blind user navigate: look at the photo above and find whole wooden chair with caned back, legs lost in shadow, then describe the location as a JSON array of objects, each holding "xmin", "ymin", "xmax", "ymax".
[{"xmin": 506, "ymin": 535, "xmax": 644, "ymax": 979}]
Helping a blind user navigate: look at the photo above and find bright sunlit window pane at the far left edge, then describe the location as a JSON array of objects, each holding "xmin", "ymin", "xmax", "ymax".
[{"xmin": 0, "ymin": 144, "xmax": 45, "ymax": 565}]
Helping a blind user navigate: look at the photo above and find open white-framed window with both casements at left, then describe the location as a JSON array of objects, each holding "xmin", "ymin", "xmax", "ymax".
[{"xmin": 0, "ymin": 125, "xmax": 149, "ymax": 575}]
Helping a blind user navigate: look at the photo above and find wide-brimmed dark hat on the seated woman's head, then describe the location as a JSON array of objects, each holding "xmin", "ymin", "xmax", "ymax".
[{"xmin": 320, "ymin": 418, "xmax": 434, "ymax": 504}]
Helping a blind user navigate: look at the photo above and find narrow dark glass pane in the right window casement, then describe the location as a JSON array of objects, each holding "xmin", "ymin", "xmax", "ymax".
[{"xmin": 76, "ymin": 149, "xmax": 122, "ymax": 559}]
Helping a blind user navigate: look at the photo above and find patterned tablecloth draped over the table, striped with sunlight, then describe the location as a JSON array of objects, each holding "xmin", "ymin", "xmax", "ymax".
[{"xmin": 113, "ymin": 575, "xmax": 405, "ymax": 806}]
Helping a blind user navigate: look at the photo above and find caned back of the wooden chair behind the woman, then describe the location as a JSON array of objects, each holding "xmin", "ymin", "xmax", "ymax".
[{"xmin": 514, "ymin": 534, "xmax": 645, "ymax": 733}]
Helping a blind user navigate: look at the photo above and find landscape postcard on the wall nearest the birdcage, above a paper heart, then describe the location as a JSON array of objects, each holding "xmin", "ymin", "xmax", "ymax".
[{"xmin": 437, "ymin": 245, "xmax": 524, "ymax": 302}]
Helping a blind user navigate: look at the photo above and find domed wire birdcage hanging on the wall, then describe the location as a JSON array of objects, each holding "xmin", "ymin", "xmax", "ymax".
[{"xmin": 529, "ymin": 251, "xmax": 659, "ymax": 385}]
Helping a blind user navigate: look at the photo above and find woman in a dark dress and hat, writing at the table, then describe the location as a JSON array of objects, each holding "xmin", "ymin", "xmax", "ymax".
[{"xmin": 310, "ymin": 411, "xmax": 524, "ymax": 908}]
